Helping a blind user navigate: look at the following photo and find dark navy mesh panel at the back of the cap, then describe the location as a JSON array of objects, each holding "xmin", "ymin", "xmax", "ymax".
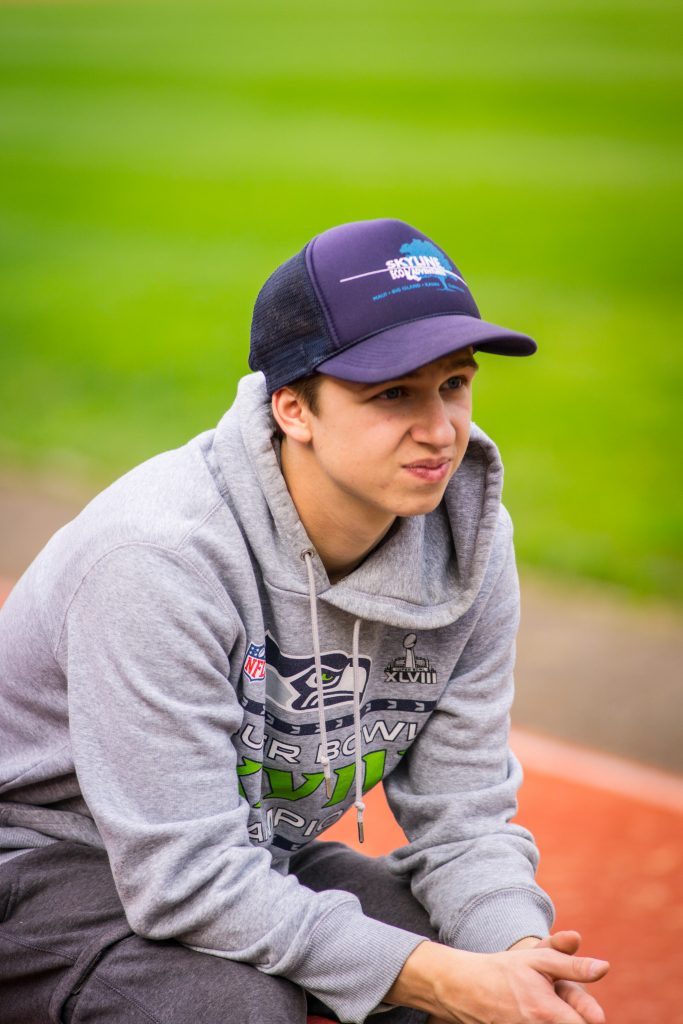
[{"xmin": 249, "ymin": 249, "xmax": 330, "ymax": 393}]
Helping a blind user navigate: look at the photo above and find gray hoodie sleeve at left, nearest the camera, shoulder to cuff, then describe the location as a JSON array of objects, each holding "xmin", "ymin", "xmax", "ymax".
[{"xmin": 57, "ymin": 544, "xmax": 423, "ymax": 1022}]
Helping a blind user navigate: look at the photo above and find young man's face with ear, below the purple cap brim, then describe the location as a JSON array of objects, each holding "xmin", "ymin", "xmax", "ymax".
[{"xmin": 301, "ymin": 348, "xmax": 477, "ymax": 519}]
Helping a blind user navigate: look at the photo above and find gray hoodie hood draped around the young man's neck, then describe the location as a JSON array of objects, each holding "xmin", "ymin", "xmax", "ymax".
[{"xmin": 214, "ymin": 373, "xmax": 503, "ymax": 630}]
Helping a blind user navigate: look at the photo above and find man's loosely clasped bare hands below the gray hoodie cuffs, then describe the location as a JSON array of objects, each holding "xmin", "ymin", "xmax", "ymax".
[{"xmin": 385, "ymin": 932, "xmax": 609, "ymax": 1024}]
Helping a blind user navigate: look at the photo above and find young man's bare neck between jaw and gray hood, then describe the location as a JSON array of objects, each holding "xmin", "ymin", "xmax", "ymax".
[{"xmin": 282, "ymin": 437, "xmax": 395, "ymax": 583}]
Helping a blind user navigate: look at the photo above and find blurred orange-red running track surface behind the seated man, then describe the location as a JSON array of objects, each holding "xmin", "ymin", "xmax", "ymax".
[{"xmin": 0, "ymin": 580, "xmax": 683, "ymax": 1024}]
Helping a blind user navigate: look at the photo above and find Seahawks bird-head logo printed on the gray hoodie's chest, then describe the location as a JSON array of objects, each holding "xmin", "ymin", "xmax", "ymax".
[{"xmin": 265, "ymin": 633, "xmax": 372, "ymax": 711}]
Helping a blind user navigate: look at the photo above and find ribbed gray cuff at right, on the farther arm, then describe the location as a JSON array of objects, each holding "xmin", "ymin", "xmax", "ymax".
[{"xmin": 442, "ymin": 889, "xmax": 554, "ymax": 953}]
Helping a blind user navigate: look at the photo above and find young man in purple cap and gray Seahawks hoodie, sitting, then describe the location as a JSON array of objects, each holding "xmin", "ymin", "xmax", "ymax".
[{"xmin": 0, "ymin": 220, "xmax": 606, "ymax": 1024}]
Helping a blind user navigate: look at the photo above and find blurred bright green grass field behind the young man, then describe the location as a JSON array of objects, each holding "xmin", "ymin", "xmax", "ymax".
[{"xmin": 0, "ymin": 0, "xmax": 683, "ymax": 599}]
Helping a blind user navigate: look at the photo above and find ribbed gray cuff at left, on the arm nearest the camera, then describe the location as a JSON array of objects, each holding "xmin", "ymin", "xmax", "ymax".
[{"xmin": 288, "ymin": 905, "xmax": 426, "ymax": 1024}]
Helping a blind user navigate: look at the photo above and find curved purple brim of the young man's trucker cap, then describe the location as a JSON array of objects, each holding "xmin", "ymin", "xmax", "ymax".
[{"xmin": 315, "ymin": 314, "xmax": 537, "ymax": 384}]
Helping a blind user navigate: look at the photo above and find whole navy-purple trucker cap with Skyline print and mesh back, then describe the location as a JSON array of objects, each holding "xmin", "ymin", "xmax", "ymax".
[{"xmin": 249, "ymin": 219, "xmax": 537, "ymax": 394}]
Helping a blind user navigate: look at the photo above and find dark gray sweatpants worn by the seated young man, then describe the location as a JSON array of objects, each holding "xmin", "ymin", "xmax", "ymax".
[{"xmin": 0, "ymin": 842, "xmax": 434, "ymax": 1024}]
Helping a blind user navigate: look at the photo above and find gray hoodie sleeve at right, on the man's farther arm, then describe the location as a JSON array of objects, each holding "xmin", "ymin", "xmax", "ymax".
[{"xmin": 385, "ymin": 513, "xmax": 553, "ymax": 952}]
